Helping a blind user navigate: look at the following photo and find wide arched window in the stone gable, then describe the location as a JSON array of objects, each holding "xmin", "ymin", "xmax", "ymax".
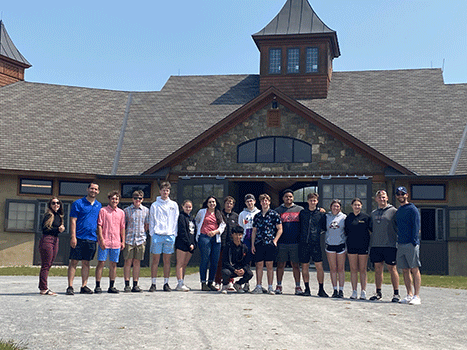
[{"xmin": 237, "ymin": 136, "xmax": 311, "ymax": 163}]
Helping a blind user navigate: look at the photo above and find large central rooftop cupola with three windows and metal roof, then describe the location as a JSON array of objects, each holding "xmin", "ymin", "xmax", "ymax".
[{"xmin": 252, "ymin": 0, "xmax": 340, "ymax": 99}]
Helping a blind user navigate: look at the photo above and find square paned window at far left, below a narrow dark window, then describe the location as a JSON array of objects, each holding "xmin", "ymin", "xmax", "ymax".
[{"xmin": 5, "ymin": 199, "xmax": 37, "ymax": 232}]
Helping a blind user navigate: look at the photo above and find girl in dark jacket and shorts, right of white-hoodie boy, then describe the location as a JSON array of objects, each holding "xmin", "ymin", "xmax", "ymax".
[{"xmin": 175, "ymin": 199, "xmax": 196, "ymax": 292}]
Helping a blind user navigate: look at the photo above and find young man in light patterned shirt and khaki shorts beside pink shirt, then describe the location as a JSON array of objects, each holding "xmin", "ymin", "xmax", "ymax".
[{"xmin": 123, "ymin": 190, "xmax": 149, "ymax": 293}]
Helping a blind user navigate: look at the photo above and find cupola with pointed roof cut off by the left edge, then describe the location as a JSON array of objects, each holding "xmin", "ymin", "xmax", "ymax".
[{"xmin": 0, "ymin": 20, "xmax": 31, "ymax": 87}]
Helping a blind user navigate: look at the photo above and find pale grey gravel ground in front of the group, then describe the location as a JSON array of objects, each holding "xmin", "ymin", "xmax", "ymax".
[{"xmin": 0, "ymin": 271, "xmax": 467, "ymax": 350}]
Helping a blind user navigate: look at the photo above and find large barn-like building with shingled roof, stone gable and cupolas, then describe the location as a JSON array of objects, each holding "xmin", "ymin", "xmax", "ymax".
[{"xmin": 0, "ymin": 0, "xmax": 467, "ymax": 275}]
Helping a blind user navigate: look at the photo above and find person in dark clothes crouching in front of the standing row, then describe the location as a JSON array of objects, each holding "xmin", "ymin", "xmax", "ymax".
[{"xmin": 221, "ymin": 225, "xmax": 253, "ymax": 294}]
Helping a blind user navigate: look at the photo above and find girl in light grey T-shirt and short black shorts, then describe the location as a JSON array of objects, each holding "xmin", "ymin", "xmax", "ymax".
[{"xmin": 321, "ymin": 199, "xmax": 347, "ymax": 298}]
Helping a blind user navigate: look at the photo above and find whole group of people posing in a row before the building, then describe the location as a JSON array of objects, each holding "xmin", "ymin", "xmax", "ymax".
[{"xmin": 39, "ymin": 182, "xmax": 421, "ymax": 304}]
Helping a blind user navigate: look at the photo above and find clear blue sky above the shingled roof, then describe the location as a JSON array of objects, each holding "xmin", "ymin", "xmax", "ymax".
[{"xmin": 0, "ymin": 0, "xmax": 467, "ymax": 91}]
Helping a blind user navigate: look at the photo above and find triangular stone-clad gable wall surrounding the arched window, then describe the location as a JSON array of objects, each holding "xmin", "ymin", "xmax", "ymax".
[{"xmin": 172, "ymin": 106, "xmax": 383, "ymax": 175}]
